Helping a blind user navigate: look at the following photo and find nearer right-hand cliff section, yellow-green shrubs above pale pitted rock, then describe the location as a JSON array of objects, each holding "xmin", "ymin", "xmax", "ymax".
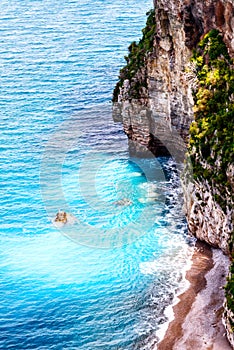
[{"xmin": 185, "ymin": 29, "xmax": 234, "ymax": 254}]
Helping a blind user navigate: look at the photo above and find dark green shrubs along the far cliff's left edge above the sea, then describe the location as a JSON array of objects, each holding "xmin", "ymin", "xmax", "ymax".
[{"xmin": 112, "ymin": 10, "xmax": 156, "ymax": 102}]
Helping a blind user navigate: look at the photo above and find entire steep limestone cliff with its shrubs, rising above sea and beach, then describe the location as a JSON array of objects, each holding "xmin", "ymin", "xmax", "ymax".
[{"xmin": 113, "ymin": 0, "xmax": 234, "ymax": 347}]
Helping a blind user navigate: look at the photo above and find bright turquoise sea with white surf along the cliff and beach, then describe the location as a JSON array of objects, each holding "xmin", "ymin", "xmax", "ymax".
[{"xmin": 0, "ymin": 0, "xmax": 192, "ymax": 350}]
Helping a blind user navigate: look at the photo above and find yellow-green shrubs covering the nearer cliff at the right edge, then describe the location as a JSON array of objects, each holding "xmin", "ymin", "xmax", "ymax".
[{"xmin": 189, "ymin": 30, "xmax": 234, "ymax": 312}]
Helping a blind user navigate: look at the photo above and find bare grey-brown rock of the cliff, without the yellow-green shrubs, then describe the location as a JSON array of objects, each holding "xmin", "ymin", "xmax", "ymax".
[{"xmin": 113, "ymin": 0, "xmax": 234, "ymax": 253}]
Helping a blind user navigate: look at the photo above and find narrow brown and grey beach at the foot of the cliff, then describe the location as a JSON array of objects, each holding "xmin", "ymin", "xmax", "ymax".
[{"xmin": 155, "ymin": 241, "xmax": 231, "ymax": 350}]
